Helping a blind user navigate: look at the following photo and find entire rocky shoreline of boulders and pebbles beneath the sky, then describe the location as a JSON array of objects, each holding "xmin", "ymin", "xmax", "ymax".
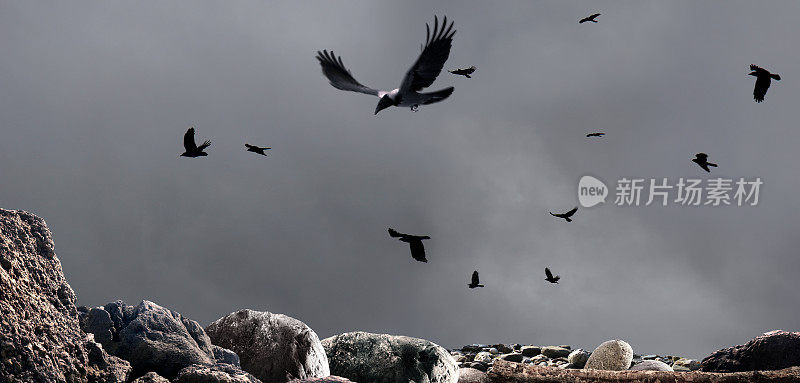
[{"xmin": 0, "ymin": 209, "xmax": 800, "ymax": 383}]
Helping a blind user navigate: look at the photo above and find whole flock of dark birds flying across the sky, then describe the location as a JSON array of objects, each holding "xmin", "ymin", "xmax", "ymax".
[{"xmin": 180, "ymin": 13, "xmax": 781, "ymax": 289}]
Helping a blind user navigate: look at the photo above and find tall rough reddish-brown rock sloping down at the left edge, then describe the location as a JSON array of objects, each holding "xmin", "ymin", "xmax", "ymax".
[{"xmin": 0, "ymin": 209, "xmax": 131, "ymax": 383}]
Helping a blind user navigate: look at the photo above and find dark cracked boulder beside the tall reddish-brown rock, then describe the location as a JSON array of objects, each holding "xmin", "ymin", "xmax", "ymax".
[{"xmin": 81, "ymin": 301, "xmax": 214, "ymax": 379}]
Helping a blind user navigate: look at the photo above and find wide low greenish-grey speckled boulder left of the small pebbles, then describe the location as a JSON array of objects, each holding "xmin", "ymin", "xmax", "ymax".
[{"xmin": 322, "ymin": 332, "xmax": 456, "ymax": 383}]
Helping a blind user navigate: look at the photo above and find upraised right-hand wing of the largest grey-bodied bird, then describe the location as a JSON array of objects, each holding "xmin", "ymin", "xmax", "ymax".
[{"xmin": 400, "ymin": 16, "xmax": 456, "ymax": 92}]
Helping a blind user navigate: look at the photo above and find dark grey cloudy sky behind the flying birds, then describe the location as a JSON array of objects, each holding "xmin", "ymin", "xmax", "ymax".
[{"xmin": 0, "ymin": 1, "xmax": 800, "ymax": 358}]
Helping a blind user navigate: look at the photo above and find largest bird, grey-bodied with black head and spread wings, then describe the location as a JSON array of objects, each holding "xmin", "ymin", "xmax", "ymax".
[{"xmin": 317, "ymin": 17, "xmax": 456, "ymax": 114}]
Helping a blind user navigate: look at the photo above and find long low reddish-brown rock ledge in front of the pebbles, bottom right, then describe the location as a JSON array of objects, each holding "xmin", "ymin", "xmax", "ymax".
[{"xmin": 489, "ymin": 360, "xmax": 800, "ymax": 383}]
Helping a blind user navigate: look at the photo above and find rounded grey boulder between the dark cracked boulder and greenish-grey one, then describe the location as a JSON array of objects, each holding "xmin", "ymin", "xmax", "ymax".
[{"xmin": 206, "ymin": 310, "xmax": 330, "ymax": 383}]
